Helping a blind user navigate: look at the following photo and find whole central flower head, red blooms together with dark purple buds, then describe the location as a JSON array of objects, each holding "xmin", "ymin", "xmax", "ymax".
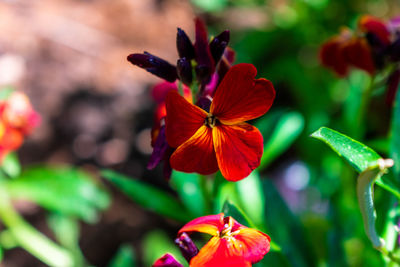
[{"xmin": 128, "ymin": 19, "xmax": 275, "ymax": 181}]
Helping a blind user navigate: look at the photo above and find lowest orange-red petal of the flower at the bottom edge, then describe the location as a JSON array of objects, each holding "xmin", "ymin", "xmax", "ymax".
[{"xmin": 190, "ymin": 237, "xmax": 251, "ymax": 267}]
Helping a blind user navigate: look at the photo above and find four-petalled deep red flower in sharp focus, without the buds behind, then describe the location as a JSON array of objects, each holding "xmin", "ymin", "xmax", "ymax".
[{"xmin": 166, "ymin": 64, "xmax": 275, "ymax": 181}]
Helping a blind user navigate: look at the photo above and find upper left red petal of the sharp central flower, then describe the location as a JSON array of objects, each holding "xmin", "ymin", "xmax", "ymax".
[{"xmin": 165, "ymin": 91, "xmax": 207, "ymax": 147}]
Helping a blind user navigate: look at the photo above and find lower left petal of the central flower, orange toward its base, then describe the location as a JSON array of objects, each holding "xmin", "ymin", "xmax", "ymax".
[{"xmin": 167, "ymin": 125, "xmax": 218, "ymax": 175}]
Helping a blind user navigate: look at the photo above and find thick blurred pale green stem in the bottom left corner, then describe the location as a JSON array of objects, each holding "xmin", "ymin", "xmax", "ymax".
[{"xmin": 0, "ymin": 188, "xmax": 73, "ymax": 267}]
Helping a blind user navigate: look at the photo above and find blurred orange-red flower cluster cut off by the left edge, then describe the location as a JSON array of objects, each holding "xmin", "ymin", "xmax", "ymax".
[{"xmin": 0, "ymin": 92, "xmax": 40, "ymax": 161}]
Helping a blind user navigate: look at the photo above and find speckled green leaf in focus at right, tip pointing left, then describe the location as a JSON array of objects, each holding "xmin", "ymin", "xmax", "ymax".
[{"xmin": 311, "ymin": 127, "xmax": 381, "ymax": 172}]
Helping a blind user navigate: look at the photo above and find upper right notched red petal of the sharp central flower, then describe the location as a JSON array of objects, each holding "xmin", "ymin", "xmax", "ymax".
[{"xmin": 210, "ymin": 64, "xmax": 275, "ymax": 124}]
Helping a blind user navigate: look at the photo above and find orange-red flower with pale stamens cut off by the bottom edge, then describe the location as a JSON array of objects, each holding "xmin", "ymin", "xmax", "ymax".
[{"xmin": 178, "ymin": 213, "xmax": 271, "ymax": 267}]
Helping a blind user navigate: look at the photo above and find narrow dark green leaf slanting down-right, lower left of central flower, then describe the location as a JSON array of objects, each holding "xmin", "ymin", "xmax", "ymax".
[{"xmin": 101, "ymin": 170, "xmax": 191, "ymax": 222}]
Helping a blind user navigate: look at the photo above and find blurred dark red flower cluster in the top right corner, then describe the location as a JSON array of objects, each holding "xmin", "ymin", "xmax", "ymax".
[{"xmin": 319, "ymin": 15, "xmax": 400, "ymax": 103}]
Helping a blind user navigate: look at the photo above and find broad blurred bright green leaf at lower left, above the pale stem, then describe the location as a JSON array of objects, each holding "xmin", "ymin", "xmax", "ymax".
[{"xmin": 6, "ymin": 166, "xmax": 110, "ymax": 222}]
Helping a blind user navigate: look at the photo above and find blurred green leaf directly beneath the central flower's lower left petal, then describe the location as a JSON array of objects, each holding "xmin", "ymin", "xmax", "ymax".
[{"xmin": 171, "ymin": 171, "xmax": 207, "ymax": 217}]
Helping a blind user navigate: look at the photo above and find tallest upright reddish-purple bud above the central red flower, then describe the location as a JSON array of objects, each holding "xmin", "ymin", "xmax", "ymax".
[{"xmin": 194, "ymin": 18, "xmax": 215, "ymax": 85}]
